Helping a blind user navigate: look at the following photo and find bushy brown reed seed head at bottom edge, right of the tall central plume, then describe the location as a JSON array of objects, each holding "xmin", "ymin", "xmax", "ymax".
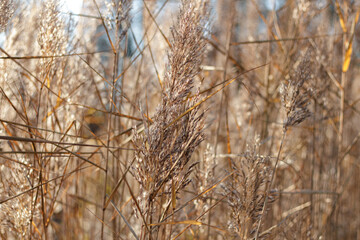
[{"xmin": 223, "ymin": 144, "xmax": 271, "ymax": 239}]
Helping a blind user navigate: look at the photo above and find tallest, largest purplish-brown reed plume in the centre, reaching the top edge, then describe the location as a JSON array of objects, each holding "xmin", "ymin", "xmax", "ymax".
[{"xmin": 134, "ymin": 1, "xmax": 207, "ymax": 208}]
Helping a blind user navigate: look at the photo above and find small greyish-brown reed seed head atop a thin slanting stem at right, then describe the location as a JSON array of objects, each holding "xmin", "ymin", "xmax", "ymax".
[{"xmin": 280, "ymin": 54, "xmax": 311, "ymax": 130}]
